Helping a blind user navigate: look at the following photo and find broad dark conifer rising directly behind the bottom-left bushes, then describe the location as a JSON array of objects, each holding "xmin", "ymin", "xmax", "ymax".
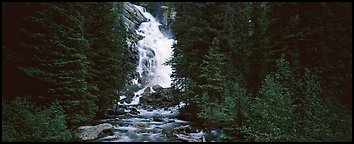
[{"xmin": 21, "ymin": 3, "xmax": 97, "ymax": 125}]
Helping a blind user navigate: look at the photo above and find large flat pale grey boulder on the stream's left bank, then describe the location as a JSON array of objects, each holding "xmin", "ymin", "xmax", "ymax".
[{"xmin": 76, "ymin": 123, "xmax": 113, "ymax": 140}]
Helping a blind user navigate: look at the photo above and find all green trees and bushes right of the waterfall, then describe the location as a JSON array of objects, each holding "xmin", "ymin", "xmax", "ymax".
[{"xmin": 168, "ymin": 2, "xmax": 352, "ymax": 141}]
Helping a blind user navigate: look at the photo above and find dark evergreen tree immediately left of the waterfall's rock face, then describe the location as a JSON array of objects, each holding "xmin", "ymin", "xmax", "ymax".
[{"xmin": 83, "ymin": 3, "xmax": 133, "ymax": 111}]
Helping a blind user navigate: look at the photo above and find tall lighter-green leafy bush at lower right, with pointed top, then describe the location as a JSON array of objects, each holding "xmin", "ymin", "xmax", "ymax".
[{"xmin": 250, "ymin": 59, "xmax": 296, "ymax": 141}]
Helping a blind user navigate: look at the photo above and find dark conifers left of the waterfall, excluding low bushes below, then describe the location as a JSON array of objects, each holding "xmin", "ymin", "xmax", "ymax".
[{"xmin": 4, "ymin": 3, "xmax": 134, "ymax": 128}]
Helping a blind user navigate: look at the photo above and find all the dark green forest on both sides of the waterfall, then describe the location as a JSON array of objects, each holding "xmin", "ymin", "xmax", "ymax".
[{"xmin": 2, "ymin": 2, "xmax": 352, "ymax": 142}]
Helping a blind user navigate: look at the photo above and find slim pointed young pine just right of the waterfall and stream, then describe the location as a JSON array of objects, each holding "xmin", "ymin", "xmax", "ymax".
[{"xmin": 192, "ymin": 38, "xmax": 225, "ymax": 138}]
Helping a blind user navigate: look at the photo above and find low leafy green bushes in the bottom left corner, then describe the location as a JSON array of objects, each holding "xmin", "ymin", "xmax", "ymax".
[{"xmin": 2, "ymin": 97, "xmax": 73, "ymax": 142}]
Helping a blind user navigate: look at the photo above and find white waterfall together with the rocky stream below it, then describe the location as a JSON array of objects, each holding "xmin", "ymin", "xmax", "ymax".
[{"xmin": 96, "ymin": 5, "xmax": 210, "ymax": 142}]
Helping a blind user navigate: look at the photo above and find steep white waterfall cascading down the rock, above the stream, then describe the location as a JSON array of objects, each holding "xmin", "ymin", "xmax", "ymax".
[{"xmin": 134, "ymin": 5, "xmax": 175, "ymax": 88}]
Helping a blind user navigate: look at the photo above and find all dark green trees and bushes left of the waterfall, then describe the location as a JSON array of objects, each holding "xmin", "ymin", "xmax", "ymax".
[{"xmin": 2, "ymin": 2, "xmax": 134, "ymax": 141}]
